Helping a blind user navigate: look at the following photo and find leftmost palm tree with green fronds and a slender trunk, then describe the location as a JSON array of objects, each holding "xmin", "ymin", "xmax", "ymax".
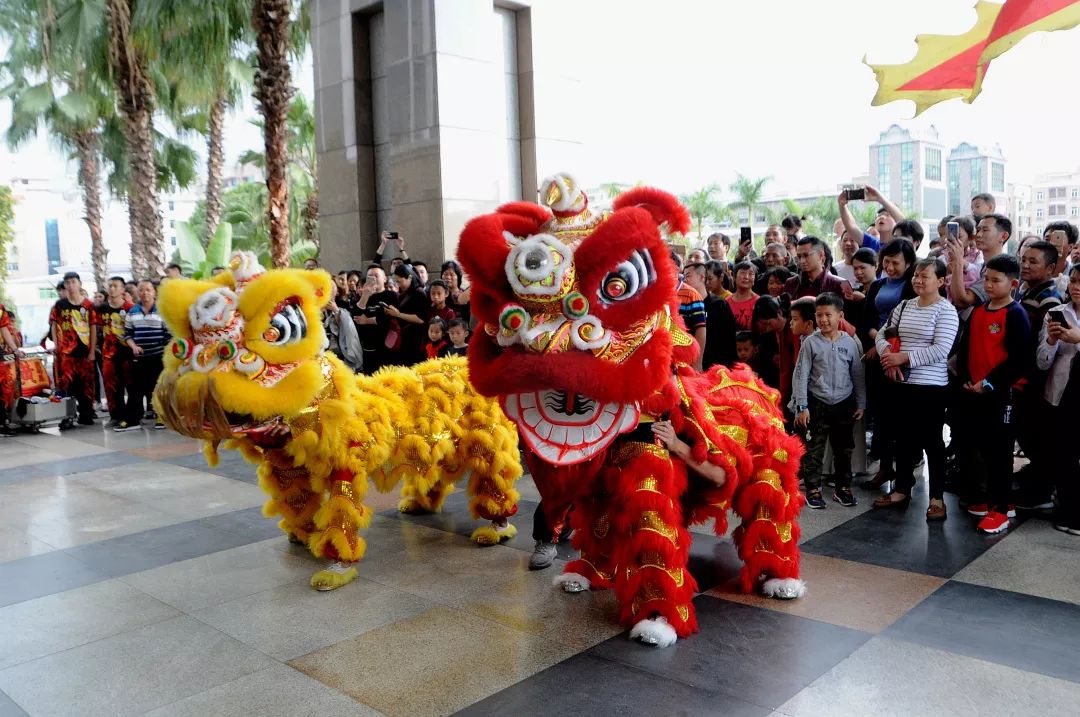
[{"xmin": 0, "ymin": 0, "xmax": 112, "ymax": 290}]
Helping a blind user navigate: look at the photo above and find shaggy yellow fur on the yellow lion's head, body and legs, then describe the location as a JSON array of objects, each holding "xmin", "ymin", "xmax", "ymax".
[{"xmin": 159, "ymin": 263, "xmax": 522, "ymax": 562}]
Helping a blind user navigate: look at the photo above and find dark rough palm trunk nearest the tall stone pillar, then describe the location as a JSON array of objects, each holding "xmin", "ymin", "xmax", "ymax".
[{"xmin": 252, "ymin": 0, "xmax": 294, "ymax": 267}]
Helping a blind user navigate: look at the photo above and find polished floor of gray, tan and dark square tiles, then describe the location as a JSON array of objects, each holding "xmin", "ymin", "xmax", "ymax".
[{"xmin": 0, "ymin": 428, "xmax": 1080, "ymax": 717}]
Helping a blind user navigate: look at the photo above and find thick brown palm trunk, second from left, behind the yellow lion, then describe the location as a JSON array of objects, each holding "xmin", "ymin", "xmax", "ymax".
[{"xmin": 107, "ymin": 0, "xmax": 164, "ymax": 279}]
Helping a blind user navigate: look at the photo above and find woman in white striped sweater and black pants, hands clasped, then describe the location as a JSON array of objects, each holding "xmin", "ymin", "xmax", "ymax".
[{"xmin": 874, "ymin": 259, "xmax": 960, "ymax": 516}]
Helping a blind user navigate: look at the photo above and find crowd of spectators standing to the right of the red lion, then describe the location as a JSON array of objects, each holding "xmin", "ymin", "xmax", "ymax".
[{"xmin": 691, "ymin": 187, "xmax": 1080, "ymax": 536}]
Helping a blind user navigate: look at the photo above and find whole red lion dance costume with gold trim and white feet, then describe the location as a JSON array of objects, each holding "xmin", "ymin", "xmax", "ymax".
[{"xmin": 458, "ymin": 175, "xmax": 805, "ymax": 646}]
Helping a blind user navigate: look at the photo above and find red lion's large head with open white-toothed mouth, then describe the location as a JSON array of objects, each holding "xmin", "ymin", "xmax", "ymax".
[{"xmin": 458, "ymin": 174, "xmax": 696, "ymax": 464}]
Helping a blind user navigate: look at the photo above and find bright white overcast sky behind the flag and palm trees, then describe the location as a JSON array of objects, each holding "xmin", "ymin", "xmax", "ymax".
[{"xmin": 0, "ymin": 0, "xmax": 1080, "ymax": 201}]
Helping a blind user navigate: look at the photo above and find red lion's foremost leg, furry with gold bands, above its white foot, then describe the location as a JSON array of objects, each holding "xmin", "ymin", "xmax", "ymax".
[{"xmin": 608, "ymin": 443, "xmax": 698, "ymax": 637}]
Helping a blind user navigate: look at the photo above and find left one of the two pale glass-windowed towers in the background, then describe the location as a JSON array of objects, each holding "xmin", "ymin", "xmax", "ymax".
[{"xmin": 869, "ymin": 124, "xmax": 946, "ymax": 224}]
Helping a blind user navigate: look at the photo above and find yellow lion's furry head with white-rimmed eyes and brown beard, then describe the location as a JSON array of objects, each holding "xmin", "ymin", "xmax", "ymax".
[{"xmin": 154, "ymin": 252, "xmax": 335, "ymax": 441}]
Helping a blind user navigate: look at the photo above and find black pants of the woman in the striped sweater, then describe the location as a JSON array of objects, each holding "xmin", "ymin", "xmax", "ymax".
[{"xmin": 886, "ymin": 383, "xmax": 946, "ymax": 500}]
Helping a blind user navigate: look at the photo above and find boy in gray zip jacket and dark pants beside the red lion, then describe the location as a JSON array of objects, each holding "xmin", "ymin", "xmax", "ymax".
[{"xmin": 792, "ymin": 293, "xmax": 866, "ymax": 509}]
